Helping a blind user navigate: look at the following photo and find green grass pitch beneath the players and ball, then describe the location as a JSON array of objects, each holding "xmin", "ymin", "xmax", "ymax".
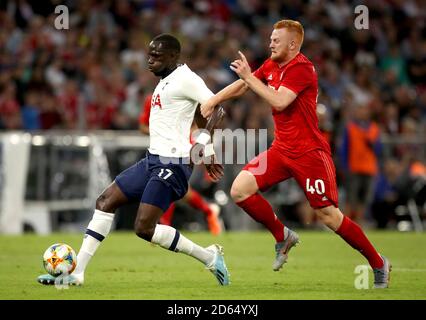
[{"xmin": 0, "ymin": 231, "xmax": 426, "ymax": 300}]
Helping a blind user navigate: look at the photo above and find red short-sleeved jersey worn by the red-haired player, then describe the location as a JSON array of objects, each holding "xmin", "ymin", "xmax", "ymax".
[{"xmin": 253, "ymin": 53, "xmax": 331, "ymax": 158}]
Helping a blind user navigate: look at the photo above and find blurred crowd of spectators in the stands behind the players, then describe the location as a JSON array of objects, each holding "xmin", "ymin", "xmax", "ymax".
[{"xmin": 0, "ymin": 0, "xmax": 426, "ymax": 230}]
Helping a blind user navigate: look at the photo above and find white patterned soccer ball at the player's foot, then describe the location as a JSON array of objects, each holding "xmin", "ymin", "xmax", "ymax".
[{"xmin": 43, "ymin": 243, "xmax": 77, "ymax": 277}]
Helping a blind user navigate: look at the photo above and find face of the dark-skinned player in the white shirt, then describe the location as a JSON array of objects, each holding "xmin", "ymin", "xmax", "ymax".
[{"xmin": 148, "ymin": 41, "xmax": 178, "ymax": 78}]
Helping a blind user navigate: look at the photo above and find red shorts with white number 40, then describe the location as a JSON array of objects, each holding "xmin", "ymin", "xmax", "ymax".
[{"xmin": 243, "ymin": 147, "xmax": 338, "ymax": 209}]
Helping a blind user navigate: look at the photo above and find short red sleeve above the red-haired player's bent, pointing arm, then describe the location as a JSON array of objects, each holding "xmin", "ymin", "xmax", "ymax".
[{"xmin": 281, "ymin": 63, "xmax": 314, "ymax": 94}]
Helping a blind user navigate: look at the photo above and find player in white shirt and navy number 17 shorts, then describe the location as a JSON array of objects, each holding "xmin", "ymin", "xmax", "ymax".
[{"xmin": 37, "ymin": 34, "xmax": 229, "ymax": 286}]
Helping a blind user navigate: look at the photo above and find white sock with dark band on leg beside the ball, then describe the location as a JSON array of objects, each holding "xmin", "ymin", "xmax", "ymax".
[{"xmin": 74, "ymin": 209, "xmax": 114, "ymax": 276}]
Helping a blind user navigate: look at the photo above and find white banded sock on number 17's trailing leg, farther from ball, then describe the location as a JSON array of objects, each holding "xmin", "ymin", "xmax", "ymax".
[{"xmin": 151, "ymin": 224, "xmax": 214, "ymax": 265}]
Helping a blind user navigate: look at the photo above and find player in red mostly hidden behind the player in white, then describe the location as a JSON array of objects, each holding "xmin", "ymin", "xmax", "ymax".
[{"xmin": 139, "ymin": 95, "xmax": 224, "ymax": 236}]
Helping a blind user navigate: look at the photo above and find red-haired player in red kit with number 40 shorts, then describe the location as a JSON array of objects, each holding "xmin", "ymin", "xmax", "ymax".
[{"xmin": 201, "ymin": 20, "xmax": 391, "ymax": 288}]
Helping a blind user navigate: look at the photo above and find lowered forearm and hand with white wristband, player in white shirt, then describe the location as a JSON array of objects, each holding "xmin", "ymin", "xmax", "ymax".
[{"xmin": 190, "ymin": 106, "xmax": 225, "ymax": 181}]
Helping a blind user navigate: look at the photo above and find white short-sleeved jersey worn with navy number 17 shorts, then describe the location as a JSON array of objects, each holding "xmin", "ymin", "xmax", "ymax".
[{"xmin": 148, "ymin": 64, "xmax": 213, "ymax": 158}]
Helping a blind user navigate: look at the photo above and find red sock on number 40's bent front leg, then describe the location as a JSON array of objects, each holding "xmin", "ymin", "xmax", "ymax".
[{"xmin": 237, "ymin": 193, "xmax": 284, "ymax": 242}]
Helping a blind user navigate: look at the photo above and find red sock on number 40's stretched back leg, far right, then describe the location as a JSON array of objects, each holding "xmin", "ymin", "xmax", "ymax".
[{"xmin": 336, "ymin": 216, "xmax": 383, "ymax": 269}]
